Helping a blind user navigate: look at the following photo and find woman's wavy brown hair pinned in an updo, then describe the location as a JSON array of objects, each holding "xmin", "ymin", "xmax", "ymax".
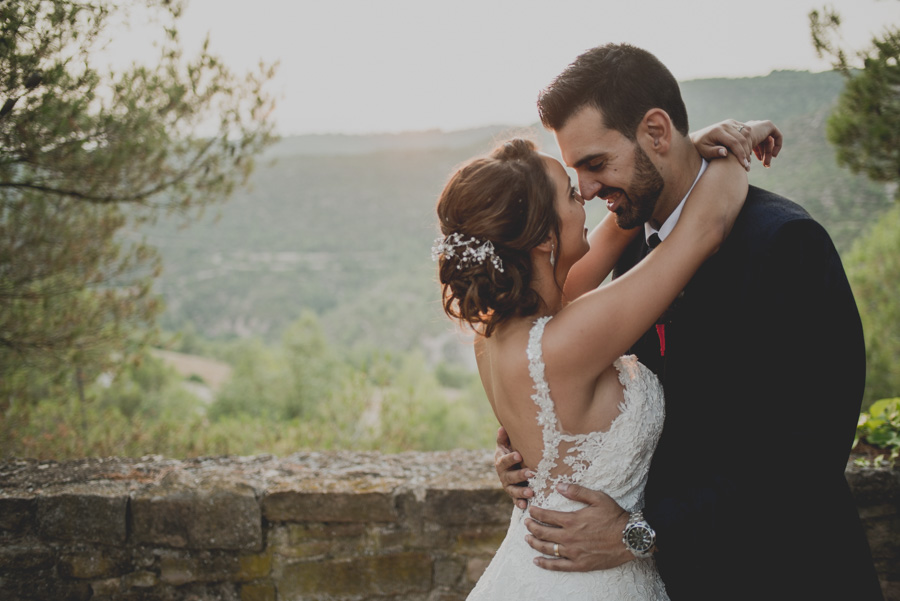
[{"xmin": 437, "ymin": 138, "xmax": 559, "ymax": 336}]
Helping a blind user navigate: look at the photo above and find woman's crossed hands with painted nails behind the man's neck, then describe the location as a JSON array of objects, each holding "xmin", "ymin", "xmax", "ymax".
[{"xmin": 690, "ymin": 119, "xmax": 784, "ymax": 171}]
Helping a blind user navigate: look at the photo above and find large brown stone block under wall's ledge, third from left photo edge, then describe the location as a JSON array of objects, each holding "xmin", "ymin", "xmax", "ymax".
[{"xmin": 131, "ymin": 483, "xmax": 262, "ymax": 551}]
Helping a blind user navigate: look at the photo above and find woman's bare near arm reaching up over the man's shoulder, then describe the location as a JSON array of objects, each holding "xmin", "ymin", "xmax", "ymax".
[{"xmin": 544, "ymin": 152, "xmax": 747, "ymax": 381}]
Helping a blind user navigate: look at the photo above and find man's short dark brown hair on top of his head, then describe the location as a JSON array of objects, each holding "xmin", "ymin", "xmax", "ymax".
[{"xmin": 538, "ymin": 44, "xmax": 688, "ymax": 140}]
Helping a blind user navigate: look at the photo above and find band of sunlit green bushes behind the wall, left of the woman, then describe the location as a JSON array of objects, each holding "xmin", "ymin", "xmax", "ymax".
[{"xmin": 0, "ymin": 314, "xmax": 496, "ymax": 459}]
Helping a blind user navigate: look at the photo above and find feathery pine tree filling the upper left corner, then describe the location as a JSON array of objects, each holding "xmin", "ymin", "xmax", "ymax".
[{"xmin": 0, "ymin": 0, "xmax": 272, "ymax": 409}]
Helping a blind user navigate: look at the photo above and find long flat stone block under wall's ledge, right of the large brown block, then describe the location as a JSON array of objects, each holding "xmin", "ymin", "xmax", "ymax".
[{"xmin": 263, "ymin": 490, "xmax": 397, "ymax": 522}]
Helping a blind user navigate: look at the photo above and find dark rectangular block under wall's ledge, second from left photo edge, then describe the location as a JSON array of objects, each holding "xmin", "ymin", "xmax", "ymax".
[{"xmin": 36, "ymin": 494, "xmax": 128, "ymax": 545}]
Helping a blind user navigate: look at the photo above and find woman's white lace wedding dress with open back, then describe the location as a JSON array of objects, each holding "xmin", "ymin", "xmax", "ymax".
[{"xmin": 468, "ymin": 317, "xmax": 668, "ymax": 601}]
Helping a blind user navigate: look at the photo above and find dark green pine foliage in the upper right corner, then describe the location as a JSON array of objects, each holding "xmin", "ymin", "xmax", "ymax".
[{"xmin": 810, "ymin": 4, "xmax": 900, "ymax": 200}]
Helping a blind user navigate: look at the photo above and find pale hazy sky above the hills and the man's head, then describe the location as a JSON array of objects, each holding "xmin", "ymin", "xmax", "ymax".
[{"xmin": 109, "ymin": 0, "xmax": 900, "ymax": 134}]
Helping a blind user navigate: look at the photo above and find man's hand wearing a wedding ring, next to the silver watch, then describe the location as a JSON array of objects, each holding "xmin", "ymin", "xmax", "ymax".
[{"xmin": 525, "ymin": 484, "xmax": 634, "ymax": 572}]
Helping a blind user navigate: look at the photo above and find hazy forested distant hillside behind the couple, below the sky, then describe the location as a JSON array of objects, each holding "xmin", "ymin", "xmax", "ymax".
[{"xmin": 147, "ymin": 71, "xmax": 891, "ymax": 358}]
